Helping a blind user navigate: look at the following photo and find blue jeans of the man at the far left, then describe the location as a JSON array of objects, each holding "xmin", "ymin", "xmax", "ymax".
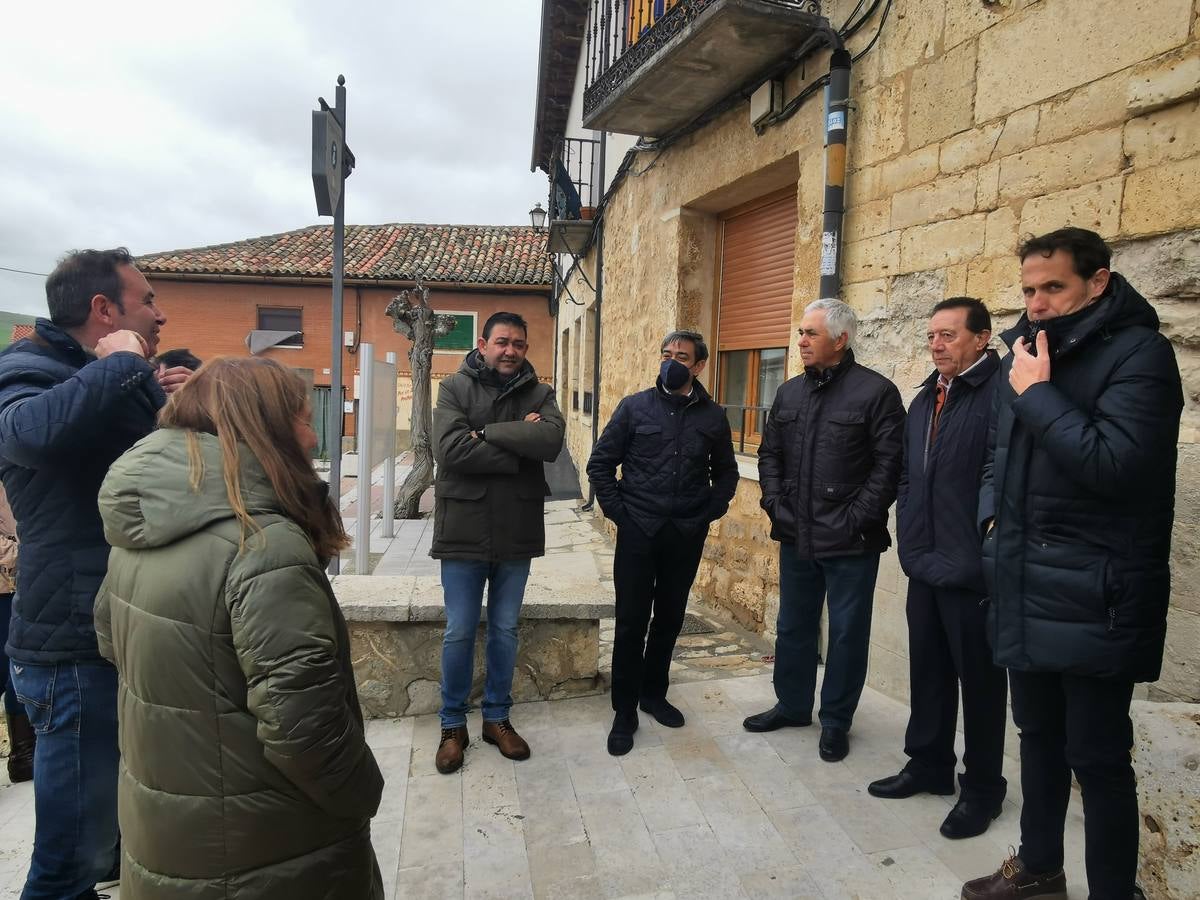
[{"xmin": 12, "ymin": 662, "xmax": 120, "ymax": 900}]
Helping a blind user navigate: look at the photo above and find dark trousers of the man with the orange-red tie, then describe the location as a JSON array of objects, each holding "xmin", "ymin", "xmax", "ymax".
[{"xmin": 904, "ymin": 580, "xmax": 1008, "ymax": 804}]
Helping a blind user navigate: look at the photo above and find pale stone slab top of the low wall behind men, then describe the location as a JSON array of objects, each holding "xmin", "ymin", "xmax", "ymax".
[{"xmin": 332, "ymin": 575, "xmax": 616, "ymax": 622}]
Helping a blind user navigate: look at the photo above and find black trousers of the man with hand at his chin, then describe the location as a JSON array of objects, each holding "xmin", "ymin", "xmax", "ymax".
[{"xmin": 1009, "ymin": 671, "xmax": 1138, "ymax": 900}]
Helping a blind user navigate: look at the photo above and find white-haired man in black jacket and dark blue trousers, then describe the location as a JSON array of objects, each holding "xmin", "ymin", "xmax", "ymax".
[{"xmin": 744, "ymin": 300, "xmax": 905, "ymax": 762}]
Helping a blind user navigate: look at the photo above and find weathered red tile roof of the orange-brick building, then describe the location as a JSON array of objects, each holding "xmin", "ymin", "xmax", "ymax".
[{"xmin": 138, "ymin": 224, "xmax": 553, "ymax": 287}]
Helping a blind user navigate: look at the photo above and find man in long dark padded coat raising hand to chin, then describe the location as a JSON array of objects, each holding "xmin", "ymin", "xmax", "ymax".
[{"xmin": 962, "ymin": 228, "xmax": 1183, "ymax": 900}]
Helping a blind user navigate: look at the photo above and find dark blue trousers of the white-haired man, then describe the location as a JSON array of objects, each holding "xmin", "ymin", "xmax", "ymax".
[{"xmin": 774, "ymin": 544, "xmax": 880, "ymax": 731}]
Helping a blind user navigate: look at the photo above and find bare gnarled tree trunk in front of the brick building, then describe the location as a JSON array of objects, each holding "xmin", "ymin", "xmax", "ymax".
[{"xmin": 388, "ymin": 278, "xmax": 455, "ymax": 518}]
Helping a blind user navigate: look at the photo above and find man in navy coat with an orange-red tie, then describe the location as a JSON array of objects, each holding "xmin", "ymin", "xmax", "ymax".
[{"xmin": 866, "ymin": 296, "xmax": 1008, "ymax": 838}]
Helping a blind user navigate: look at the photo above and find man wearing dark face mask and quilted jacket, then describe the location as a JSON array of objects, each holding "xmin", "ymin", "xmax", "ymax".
[{"xmin": 588, "ymin": 331, "xmax": 738, "ymax": 756}]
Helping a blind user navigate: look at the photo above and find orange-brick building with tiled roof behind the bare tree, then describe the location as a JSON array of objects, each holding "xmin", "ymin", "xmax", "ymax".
[{"xmin": 138, "ymin": 224, "xmax": 554, "ymax": 451}]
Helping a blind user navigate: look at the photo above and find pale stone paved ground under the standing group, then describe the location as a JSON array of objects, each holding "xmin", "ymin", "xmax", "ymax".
[{"xmin": 0, "ymin": 502, "xmax": 1087, "ymax": 900}]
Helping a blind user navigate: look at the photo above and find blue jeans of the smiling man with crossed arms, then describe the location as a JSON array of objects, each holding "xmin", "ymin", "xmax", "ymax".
[{"xmin": 442, "ymin": 559, "xmax": 529, "ymax": 728}]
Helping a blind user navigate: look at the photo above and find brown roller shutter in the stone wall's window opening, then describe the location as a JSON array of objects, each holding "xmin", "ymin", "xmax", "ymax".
[{"xmin": 716, "ymin": 188, "xmax": 798, "ymax": 350}]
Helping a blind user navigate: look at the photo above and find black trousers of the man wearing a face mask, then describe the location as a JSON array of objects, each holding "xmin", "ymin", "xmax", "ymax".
[{"xmin": 612, "ymin": 522, "xmax": 708, "ymax": 712}]
